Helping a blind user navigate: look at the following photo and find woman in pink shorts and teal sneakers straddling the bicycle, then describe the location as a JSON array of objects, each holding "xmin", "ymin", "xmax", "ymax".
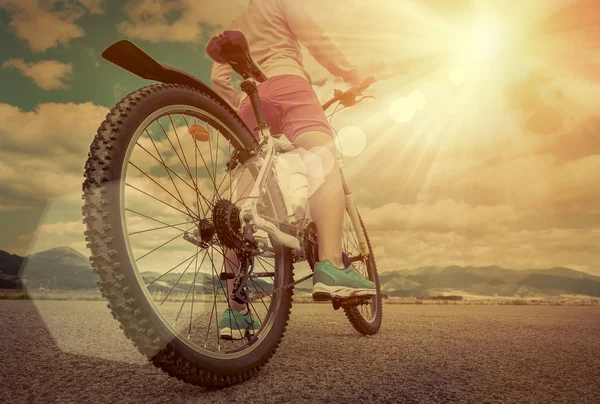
[{"xmin": 212, "ymin": 0, "xmax": 375, "ymax": 339}]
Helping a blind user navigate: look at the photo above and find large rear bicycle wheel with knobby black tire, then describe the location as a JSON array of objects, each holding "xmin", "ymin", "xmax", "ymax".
[{"xmin": 83, "ymin": 84, "xmax": 293, "ymax": 387}]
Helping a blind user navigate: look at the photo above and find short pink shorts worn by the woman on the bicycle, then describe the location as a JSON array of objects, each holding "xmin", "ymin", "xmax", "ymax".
[{"xmin": 240, "ymin": 74, "xmax": 333, "ymax": 142}]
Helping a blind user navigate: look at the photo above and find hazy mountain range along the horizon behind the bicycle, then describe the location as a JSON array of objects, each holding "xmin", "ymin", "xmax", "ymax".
[{"xmin": 0, "ymin": 247, "xmax": 600, "ymax": 297}]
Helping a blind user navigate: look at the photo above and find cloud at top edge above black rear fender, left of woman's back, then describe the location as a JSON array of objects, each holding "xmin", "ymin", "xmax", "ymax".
[{"xmin": 117, "ymin": 0, "xmax": 247, "ymax": 43}]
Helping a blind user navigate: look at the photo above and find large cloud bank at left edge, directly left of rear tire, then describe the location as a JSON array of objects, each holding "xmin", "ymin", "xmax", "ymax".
[{"xmin": 0, "ymin": 102, "xmax": 108, "ymax": 209}]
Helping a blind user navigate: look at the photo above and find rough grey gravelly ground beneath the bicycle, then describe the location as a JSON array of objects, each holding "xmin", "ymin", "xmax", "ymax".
[{"xmin": 0, "ymin": 301, "xmax": 600, "ymax": 403}]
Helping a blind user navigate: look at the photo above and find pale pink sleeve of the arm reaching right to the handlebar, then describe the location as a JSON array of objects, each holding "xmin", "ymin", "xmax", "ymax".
[{"xmin": 281, "ymin": 0, "xmax": 361, "ymax": 85}]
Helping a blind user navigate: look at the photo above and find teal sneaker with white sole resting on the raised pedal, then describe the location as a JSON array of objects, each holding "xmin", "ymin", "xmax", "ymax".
[{"xmin": 313, "ymin": 260, "xmax": 376, "ymax": 300}]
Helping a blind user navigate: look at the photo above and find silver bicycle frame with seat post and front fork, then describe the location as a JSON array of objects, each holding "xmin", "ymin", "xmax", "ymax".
[{"xmin": 240, "ymin": 79, "xmax": 369, "ymax": 257}]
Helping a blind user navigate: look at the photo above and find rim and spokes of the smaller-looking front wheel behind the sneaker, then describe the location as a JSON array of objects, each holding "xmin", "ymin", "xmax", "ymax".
[{"xmin": 342, "ymin": 212, "xmax": 378, "ymax": 323}]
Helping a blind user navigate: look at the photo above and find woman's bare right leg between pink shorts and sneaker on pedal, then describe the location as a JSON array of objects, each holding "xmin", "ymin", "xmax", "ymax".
[{"xmin": 294, "ymin": 131, "xmax": 345, "ymax": 268}]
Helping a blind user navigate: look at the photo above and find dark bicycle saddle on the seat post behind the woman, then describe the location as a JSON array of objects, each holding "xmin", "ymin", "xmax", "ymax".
[{"xmin": 206, "ymin": 30, "xmax": 267, "ymax": 83}]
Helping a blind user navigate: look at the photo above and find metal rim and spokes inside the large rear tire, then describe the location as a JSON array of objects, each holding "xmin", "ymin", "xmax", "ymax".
[{"xmin": 119, "ymin": 105, "xmax": 283, "ymax": 359}]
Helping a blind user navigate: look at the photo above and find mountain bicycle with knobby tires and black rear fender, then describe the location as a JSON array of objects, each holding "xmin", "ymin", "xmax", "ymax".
[{"xmin": 82, "ymin": 31, "xmax": 382, "ymax": 387}]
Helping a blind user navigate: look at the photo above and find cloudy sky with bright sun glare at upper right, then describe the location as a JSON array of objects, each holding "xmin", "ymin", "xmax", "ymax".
[{"xmin": 0, "ymin": 0, "xmax": 600, "ymax": 275}]
